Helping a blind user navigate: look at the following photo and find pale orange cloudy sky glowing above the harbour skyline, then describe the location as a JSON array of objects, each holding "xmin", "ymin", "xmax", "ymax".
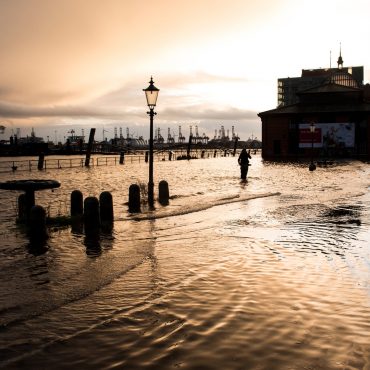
[{"xmin": 0, "ymin": 0, "xmax": 370, "ymax": 141}]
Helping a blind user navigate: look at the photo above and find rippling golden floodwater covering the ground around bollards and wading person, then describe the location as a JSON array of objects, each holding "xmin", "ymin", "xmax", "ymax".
[{"xmin": 0, "ymin": 155, "xmax": 370, "ymax": 370}]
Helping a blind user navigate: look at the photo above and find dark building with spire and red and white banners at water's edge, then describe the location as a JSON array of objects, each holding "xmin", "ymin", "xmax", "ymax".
[{"xmin": 258, "ymin": 56, "xmax": 370, "ymax": 160}]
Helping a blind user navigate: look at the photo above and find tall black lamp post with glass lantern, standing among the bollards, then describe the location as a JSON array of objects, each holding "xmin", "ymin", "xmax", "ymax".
[{"xmin": 143, "ymin": 77, "xmax": 159, "ymax": 208}]
